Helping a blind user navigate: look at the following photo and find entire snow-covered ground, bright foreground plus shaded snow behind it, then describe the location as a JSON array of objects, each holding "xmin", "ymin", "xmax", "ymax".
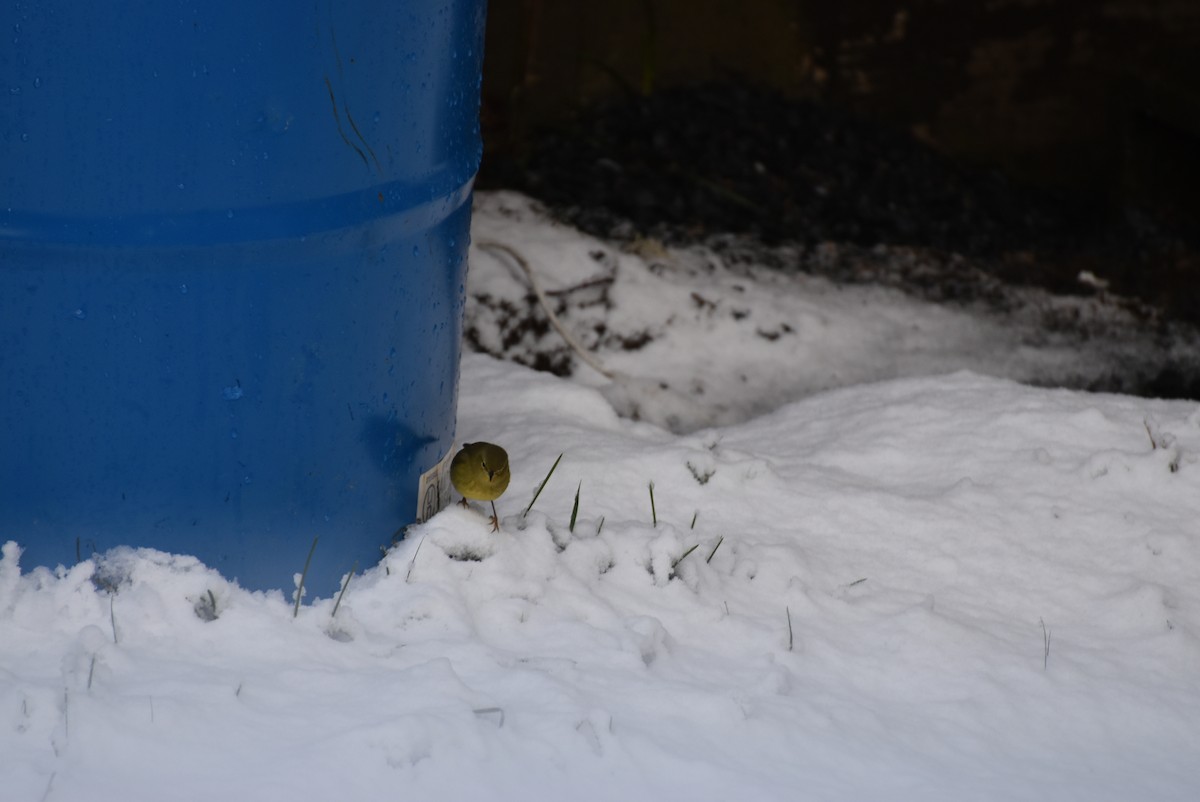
[{"xmin": 0, "ymin": 194, "xmax": 1200, "ymax": 802}]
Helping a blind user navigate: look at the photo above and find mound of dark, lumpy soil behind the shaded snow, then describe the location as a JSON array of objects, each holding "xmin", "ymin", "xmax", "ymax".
[{"xmin": 479, "ymin": 84, "xmax": 1200, "ymax": 331}]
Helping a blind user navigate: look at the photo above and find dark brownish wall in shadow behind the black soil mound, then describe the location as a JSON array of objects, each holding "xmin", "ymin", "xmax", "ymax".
[{"xmin": 484, "ymin": 0, "xmax": 1200, "ymax": 225}]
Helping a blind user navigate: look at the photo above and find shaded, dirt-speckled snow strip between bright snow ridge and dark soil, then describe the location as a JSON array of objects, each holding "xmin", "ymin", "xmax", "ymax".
[{"xmin": 467, "ymin": 192, "xmax": 1200, "ymax": 431}]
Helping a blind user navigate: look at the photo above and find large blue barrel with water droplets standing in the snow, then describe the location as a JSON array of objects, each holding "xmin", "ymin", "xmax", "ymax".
[{"xmin": 0, "ymin": 0, "xmax": 485, "ymax": 594}]
